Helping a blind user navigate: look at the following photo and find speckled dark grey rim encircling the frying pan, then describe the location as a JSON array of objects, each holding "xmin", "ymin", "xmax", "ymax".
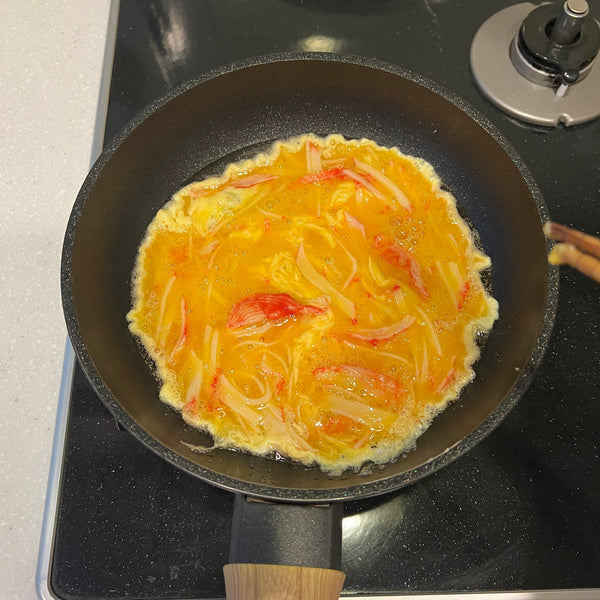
[{"xmin": 61, "ymin": 52, "xmax": 558, "ymax": 503}]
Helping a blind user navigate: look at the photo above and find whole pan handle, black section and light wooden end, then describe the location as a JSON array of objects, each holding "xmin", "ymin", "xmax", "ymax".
[{"xmin": 223, "ymin": 494, "xmax": 345, "ymax": 600}]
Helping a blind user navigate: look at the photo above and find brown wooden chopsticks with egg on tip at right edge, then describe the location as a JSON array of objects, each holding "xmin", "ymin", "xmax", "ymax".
[{"xmin": 544, "ymin": 221, "xmax": 600, "ymax": 283}]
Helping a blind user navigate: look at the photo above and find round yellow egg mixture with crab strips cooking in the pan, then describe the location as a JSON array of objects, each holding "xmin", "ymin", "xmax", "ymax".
[{"xmin": 127, "ymin": 135, "xmax": 498, "ymax": 475}]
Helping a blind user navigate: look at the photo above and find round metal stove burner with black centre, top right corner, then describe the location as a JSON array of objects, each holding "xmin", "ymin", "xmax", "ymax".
[{"xmin": 471, "ymin": 0, "xmax": 600, "ymax": 126}]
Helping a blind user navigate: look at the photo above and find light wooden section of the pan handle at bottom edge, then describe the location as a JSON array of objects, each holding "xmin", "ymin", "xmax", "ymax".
[{"xmin": 223, "ymin": 563, "xmax": 345, "ymax": 600}]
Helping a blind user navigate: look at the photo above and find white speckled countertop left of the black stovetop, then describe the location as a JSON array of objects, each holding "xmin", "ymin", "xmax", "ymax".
[{"xmin": 0, "ymin": 0, "xmax": 110, "ymax": 600}]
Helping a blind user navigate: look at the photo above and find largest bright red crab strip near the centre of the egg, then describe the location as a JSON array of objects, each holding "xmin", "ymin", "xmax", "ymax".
[{"xmin": 227, "ymin": 294, "xmax": 325, "ymax": 329}]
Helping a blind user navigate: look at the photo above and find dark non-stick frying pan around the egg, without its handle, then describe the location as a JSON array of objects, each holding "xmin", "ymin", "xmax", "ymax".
[{"xmin": 61, "ymin": 54, "xmax": 558, "ymax": 598}]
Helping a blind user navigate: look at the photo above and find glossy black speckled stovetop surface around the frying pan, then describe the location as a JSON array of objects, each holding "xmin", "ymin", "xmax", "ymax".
[{"xmin": 49, "ymin": 0, "xmax": 600, "ymax": 599}]
